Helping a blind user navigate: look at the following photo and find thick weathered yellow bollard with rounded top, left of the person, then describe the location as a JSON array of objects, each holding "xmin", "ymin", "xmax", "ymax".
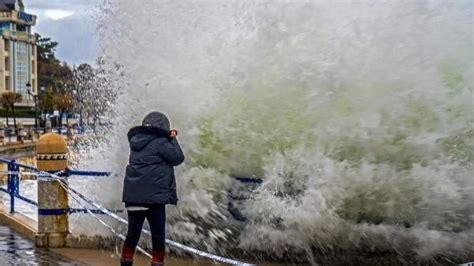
[{"xmin": 35, "ymin": 133, "xmax": 69, "ymax": 247}]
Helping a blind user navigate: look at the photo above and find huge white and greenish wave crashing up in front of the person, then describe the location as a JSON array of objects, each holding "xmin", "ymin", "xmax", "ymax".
[{"xmin": 75, "ymin": 0, "xmax": 474, "ymax": 261}]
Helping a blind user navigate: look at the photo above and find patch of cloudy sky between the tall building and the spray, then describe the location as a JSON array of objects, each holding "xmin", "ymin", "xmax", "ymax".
[{"xmin": 23, "ymin": 0, "xmax": 103, "ymax": 65}]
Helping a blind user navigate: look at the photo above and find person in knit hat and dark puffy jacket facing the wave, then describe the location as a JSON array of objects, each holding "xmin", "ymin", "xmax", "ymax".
[{"xmin": 120, "ymin": 112, "xmax": 184, "ymax": 266}]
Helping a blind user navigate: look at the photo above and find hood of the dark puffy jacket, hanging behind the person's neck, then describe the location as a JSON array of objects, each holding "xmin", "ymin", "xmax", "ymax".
[{"xmin": 127, "ymin": 126, "xmax": 169, "ymax": 151}]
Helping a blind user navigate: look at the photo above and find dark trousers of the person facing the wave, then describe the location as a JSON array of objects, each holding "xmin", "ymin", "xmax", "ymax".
[{"xmin": 122, "ymin": 205, "xmax": 166, "ymax": 262}]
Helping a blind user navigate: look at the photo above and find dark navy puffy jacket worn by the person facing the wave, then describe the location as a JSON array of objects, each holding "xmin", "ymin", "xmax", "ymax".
[{"xmin": 122, "ymin": 126, "xmax": 184, "ymax": 206}]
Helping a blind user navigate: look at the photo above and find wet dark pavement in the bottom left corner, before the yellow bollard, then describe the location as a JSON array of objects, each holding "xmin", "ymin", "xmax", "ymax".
[{"xmin": 0, "ymin": 224, "xmax": 81, "ymax": 265}]
